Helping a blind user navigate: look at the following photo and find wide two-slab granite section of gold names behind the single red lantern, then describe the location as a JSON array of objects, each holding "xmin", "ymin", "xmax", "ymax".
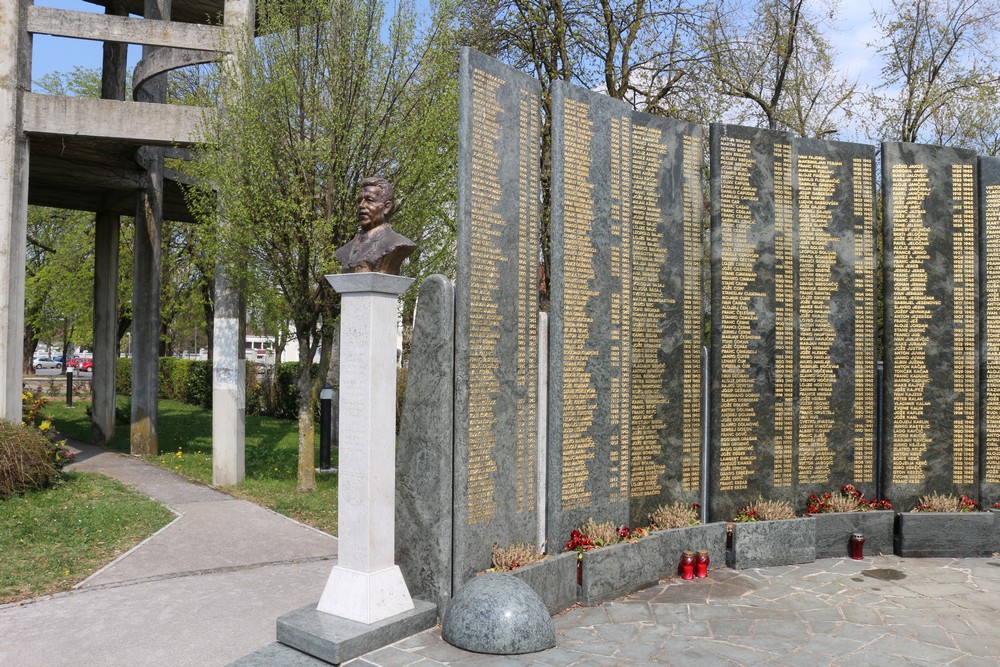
[{"xmin": 710, "ymin": 124, "xmax": 876, "ymax": 520}]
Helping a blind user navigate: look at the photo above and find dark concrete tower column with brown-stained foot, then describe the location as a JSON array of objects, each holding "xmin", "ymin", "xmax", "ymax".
[{"xmin": 129, "ymin": 0, "xmax": 170, "ymax": 456}]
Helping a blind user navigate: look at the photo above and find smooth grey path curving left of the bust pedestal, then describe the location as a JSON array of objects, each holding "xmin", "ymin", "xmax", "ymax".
[{"xmin": 0, "ymin": 443, "xmax": 337, "ymax": 667}]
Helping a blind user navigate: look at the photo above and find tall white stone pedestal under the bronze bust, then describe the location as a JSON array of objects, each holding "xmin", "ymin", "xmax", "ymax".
[{"xmin": 316, "ymin": 273, "xmax": 414, "ymax": 624}]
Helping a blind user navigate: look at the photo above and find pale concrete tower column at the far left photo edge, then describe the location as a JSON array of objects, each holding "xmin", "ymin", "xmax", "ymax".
[{"xmin": 0, "ymin": 0, "xmax": 31, "ymax": 423}]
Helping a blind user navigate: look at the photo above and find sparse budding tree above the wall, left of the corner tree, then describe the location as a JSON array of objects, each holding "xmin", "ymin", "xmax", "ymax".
[{"xmin": 704, "ymin": 0, "xmax": 855, "ymax": 137}]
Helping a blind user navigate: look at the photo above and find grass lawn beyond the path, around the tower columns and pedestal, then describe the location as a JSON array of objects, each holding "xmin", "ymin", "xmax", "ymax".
[{"xmin": 42, "ymin": 397, "xmax": 337, "ymax": 535}]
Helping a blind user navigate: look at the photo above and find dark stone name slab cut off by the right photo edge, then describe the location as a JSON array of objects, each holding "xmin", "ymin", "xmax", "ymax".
[{"xmin": 977, "ymin": 157, "xmax": 1000, "ymax": 507}]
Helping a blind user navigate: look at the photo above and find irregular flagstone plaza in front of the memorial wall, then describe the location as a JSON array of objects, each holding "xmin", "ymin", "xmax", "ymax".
[{"xmin": 346, "ymin": 556, "xmax": 1000, "ymax": 667}]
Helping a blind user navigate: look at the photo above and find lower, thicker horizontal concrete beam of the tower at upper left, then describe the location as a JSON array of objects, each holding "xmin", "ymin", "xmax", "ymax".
[{"xmin": 22, "ymin": 93, "xmax": 216, "ymax": 146}]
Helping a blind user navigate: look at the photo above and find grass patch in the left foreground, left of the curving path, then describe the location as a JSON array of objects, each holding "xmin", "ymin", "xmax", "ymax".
[{"xmin": 0, "ymin": 473, "xmax": 174, "ymax": 604}]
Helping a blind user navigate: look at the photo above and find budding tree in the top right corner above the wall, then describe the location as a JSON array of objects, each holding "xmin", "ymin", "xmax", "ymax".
[{"xmin": 868, "ymin": 0, "xmax": 1000, "ymax": 142}]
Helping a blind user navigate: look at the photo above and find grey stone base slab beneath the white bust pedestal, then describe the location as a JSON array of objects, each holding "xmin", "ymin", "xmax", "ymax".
[{"xmin": 276, "ymin": 599, "xmax": 437, "ymax": 665}]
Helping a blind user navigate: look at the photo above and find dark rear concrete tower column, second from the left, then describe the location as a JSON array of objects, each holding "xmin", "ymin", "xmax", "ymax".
[{"xmin": 90, "ymin": 2, "xmax": 128, "ymax": 445}]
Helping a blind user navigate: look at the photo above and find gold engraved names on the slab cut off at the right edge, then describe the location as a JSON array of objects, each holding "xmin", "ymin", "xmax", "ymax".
[{"xmin": 983, "ymin": 185, "xmax": 1000, "ymax": 484}]
